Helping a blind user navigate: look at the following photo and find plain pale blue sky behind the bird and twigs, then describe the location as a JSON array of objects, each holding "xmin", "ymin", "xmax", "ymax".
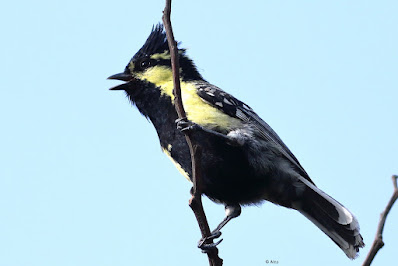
[{"xmin": 0, "ymin": 0, "xmax": 398, "ymax": 266}]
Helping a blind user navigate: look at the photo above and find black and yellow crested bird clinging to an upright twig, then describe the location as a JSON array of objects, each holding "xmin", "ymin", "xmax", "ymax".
[{"xmin": 108, "ymin": 23, "xmax": 365, "ymax": 259}]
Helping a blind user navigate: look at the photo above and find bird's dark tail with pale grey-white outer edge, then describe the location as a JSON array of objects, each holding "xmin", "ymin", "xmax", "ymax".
[{"xmin": 295, "ymin": 180, "xmax": 365, "ymax": 259}]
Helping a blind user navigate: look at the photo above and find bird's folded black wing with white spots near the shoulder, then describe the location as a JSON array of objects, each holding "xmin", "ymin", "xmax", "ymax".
[{"xmin": 196, "ymin": 82, "xmax": 315, "ymax": 185}]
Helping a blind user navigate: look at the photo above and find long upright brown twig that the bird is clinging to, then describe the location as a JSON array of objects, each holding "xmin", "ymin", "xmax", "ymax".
[{"xmin": 162, "ymin": 0, "xmax": 223, "ymax": 266}]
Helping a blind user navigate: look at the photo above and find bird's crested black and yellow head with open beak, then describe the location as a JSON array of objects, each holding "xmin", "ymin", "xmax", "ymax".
[{"xmin": 108, "ymin": 24, "xmax": 202, "ymax": 96}]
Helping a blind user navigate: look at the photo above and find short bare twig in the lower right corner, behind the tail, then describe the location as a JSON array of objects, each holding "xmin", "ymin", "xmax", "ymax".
[{"xmin": 362, "ymin": 175, "xmax": 398, "ymax": 266}]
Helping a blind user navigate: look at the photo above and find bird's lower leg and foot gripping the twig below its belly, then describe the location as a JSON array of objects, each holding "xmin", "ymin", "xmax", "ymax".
[{"xmin": 198, "ymin": 205, "xmax": 242, "ymax": 252}]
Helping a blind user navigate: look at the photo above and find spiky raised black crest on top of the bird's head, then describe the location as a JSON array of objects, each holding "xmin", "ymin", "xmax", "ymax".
[{"xmin": 133, "ymin": 23, "xmax": 169, "ymax": 59}]
